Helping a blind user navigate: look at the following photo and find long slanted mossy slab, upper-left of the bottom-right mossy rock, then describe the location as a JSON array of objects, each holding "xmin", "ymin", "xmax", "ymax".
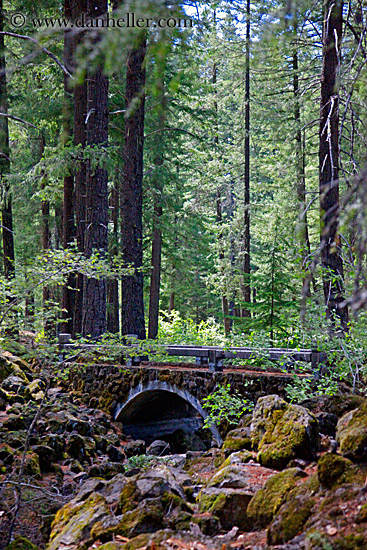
[{"xmin": 246, "ymin": 468, "xmax": 306, "ymax": 529}]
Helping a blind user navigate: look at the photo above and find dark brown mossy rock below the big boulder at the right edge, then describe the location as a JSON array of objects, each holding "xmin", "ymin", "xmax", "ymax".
[{"xmin": 317, "ymin": 453, "xmax": 363, "ymax": 489}]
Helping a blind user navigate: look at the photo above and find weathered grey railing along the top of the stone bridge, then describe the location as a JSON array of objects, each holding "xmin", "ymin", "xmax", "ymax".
[{"xmin": 59, "ymin": 333, "xmax": 327, "ymax": 372}]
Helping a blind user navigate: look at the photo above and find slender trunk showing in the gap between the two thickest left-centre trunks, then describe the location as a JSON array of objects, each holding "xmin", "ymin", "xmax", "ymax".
[{"xmin": 107, "ymin": 182, "xmax": 120, "ymax": 334}]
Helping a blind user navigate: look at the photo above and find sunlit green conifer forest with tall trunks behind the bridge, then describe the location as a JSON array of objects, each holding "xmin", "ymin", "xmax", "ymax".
[{"xmin": 0, "ymin": 0, "xmax": 367, "ymax": 358}]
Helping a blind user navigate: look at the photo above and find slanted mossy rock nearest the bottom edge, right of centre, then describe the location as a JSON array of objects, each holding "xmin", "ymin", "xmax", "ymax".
[{"xmin": 267, "ymin": 495, "xmax": 315, "ymax": 545}]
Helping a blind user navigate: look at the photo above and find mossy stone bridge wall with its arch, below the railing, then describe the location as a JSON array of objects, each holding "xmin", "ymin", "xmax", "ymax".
[{"xmin": 69, "ymin": 364, "xmax": 290, "ymax": 443}]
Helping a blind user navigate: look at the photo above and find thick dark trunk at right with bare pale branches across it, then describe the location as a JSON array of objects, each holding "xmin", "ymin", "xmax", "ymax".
[{"xmin": 319, "ymin": 0, "xmax": 348, "ymax": 330}]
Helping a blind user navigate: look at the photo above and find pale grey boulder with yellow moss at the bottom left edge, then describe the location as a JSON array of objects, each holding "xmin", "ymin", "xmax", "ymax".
[{"xmin": 46, "ymin": 493, "xmax": 112, "ymax": 550}]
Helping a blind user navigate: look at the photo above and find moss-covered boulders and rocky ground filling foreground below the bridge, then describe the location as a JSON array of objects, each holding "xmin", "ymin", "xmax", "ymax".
[{"xmin": 0, "ymin": 352, "xmax": 367, "ymax": 550}]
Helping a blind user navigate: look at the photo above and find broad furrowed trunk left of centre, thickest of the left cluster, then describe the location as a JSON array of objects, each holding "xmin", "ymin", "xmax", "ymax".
[{"xmin": 82, "ymin": 0, "xmax": 108, "ymax": 338}]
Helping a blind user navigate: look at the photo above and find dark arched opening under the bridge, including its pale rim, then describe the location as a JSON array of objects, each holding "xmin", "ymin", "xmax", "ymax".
[{"xmin": 114, "ymin": 381, "xmax": 222, "ymax": 444}]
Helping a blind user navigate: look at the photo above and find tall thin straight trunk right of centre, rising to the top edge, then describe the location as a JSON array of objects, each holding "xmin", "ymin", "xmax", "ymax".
[{"xmin": 242, "ymin": 0, "xmax": 251, "ymax": 317}]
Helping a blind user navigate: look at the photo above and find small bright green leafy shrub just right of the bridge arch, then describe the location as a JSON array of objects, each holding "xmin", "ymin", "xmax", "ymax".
[{"xmin": 203, "ymin": 383, "xmax": 253, "ymax": 428}]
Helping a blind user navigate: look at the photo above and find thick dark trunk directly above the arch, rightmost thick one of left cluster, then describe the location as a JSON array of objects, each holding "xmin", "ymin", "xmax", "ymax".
[{"xmin": 121, "ymin": 36, "xmax": 146, "ymax": 339}]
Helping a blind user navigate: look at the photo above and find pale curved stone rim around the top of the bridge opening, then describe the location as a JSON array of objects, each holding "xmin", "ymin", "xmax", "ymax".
[{"xmin": 114, "ymin": 380, "xmax": 222, "ymax": 445}]
